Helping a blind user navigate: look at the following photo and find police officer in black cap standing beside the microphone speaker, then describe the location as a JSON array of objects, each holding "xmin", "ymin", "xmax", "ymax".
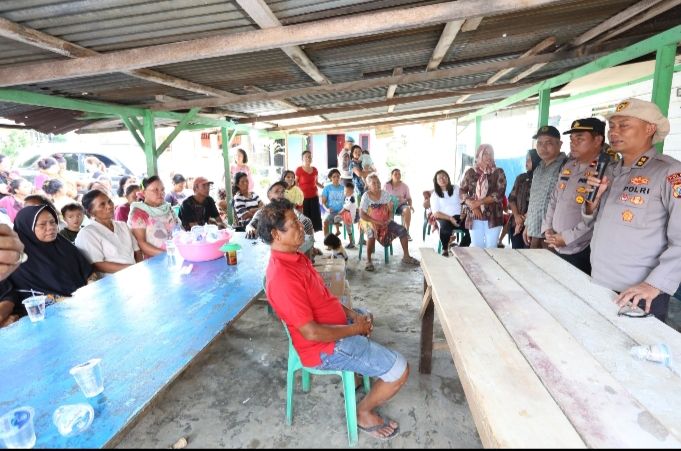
[{"xmin": 541, "ymin": 117, "xmax": 605, "ymax": 275}]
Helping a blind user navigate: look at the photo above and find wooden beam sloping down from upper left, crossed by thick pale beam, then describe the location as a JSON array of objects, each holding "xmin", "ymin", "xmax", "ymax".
[{"xmin": 0, "ymin": 17, "xmax": 236, "ymax": 97}]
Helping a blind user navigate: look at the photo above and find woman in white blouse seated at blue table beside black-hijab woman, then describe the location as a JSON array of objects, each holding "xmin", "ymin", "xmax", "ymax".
[{"xmin": 75, "ymin": 190, "xmax": 142, "ymax": 275}]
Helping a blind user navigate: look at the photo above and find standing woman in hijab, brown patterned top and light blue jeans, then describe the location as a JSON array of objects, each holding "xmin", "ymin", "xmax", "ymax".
[{"xmin": 459, "ymin": 144, "xmax": 506, "ymax": 247}]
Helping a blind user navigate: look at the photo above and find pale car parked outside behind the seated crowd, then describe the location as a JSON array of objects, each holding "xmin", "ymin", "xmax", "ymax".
[{"xmin": 15, "ymin": 146, "xmax": 145, "ymax": 189}]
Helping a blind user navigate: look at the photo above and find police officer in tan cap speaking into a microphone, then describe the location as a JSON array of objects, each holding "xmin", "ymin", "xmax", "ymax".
[{"xmin": 584, "ymin": 99, "xmax": 681, "ymax": 321}]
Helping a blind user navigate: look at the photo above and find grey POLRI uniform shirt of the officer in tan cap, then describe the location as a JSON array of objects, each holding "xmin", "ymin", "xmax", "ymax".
[{"xmin": 585, "ymin": 147, "xmax": 681, "ymax": 294}]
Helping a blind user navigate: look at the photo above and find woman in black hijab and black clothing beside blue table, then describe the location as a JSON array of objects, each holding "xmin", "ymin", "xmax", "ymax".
[{"xmin": 10, "ymin": 205, "xmax": 93, "ymax": 306}]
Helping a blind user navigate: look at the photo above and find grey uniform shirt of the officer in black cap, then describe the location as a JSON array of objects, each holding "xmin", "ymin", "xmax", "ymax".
[{"xmin": 541, "ymin": 159, "xmax": 598, "ymax": 255}]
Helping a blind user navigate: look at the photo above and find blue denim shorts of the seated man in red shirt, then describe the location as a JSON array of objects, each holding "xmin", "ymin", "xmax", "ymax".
[{"xmin": 316, "ymin": 335, "xmax": 407, "ymax": 382}]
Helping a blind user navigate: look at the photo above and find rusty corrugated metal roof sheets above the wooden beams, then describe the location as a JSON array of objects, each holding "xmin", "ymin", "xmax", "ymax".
[{"xmin": 0, "ymin": 0, "xmax": 681, "ymax": 132}]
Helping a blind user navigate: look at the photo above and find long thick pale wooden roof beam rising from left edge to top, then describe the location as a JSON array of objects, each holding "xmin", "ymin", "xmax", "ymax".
[{"xmin": 0, "ymin": 0, "xmax": 559, "ymax": 86}]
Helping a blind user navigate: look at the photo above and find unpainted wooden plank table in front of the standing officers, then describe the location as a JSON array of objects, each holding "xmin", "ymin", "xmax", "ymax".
[{"xmin": 419, "ymin": 248, "xmax": 681, "ymax": 448}]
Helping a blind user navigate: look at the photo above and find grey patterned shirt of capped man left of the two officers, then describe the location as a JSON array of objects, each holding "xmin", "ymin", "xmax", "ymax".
[{"xmin": 525, "ymin": 152, "xmax": 567, "ymax": 238}]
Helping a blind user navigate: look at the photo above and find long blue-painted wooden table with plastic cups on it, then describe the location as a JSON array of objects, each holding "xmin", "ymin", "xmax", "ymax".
[{"xmin": 0, "ymin": 233, "xmax": 269, "ymax": 448}]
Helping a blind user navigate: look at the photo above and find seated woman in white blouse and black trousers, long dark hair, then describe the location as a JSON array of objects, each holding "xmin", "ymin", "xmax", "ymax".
[{"xmin": 430, "ymin": 169, "xmax": 471, "ymax": 257}]
